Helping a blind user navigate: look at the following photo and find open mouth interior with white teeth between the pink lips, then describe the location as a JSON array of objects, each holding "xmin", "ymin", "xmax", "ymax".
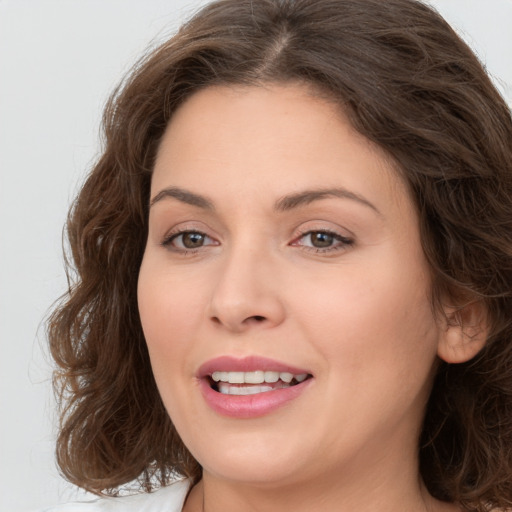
[{"xmin": 206, "ymin": 370, "xmax": 312, "ymax": 396}]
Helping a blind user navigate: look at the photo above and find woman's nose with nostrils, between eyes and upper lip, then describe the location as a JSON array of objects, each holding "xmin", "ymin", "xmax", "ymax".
[{"xmin": 209, "ymin": 247, "xmax": 285, "ymax": 333}]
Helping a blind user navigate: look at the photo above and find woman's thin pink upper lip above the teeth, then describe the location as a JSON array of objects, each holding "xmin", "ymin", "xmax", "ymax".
[{"xmin": 197, "ymin": 356, "xmax": 311, "ymax": 378}]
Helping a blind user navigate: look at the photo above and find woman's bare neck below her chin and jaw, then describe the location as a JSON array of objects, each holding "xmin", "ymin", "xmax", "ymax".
[{"xmin": 184, "ymin": 452, "xmax": 460, "ymax": 512}]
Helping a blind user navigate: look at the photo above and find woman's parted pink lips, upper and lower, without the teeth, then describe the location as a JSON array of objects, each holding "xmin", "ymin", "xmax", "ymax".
[{"xmin": 197, "ymin": 356, "xmax": 314, "ymax": 419}]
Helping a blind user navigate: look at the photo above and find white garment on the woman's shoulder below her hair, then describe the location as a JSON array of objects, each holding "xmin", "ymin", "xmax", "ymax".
[{"xmin": 34, "ymin": 480, "xmax": 190, "ymax": 512}]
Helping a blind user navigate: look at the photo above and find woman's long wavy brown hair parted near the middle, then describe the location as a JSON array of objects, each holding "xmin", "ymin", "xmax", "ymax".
[{"xmin": 48, "ymin": 0, "xmax": 512, "ymax": 511}]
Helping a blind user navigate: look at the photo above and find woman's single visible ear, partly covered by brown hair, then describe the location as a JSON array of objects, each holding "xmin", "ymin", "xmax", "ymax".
[{"xmin": 437, "ymin": 301, "xmax": 489, "ymax": 363}]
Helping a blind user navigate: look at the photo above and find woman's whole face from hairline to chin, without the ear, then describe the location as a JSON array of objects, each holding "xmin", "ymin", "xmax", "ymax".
[{"xmin": 138, "ymin": 85, "xmax": 443, "ymax": 486}]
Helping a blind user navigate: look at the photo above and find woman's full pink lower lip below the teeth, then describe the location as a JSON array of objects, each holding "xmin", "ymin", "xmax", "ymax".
[{"xmin": 200, "ymin": 378, "xmax": 313, "ymax": 418}]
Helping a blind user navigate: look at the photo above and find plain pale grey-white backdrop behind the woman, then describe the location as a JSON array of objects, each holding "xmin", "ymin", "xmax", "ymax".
[{"xmin": 0, "ymin": 0, "xmax": 512, "ymax": 512}]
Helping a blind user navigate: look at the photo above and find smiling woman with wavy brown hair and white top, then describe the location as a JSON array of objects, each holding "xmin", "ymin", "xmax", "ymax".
[{"xmin": 43, "ymin": 0, "xmax": 512, "ymax": 512}]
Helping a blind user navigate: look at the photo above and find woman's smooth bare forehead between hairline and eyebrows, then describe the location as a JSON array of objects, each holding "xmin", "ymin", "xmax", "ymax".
[{"xmin": 152, "ymin": 84, "xmax": 408, "ymax": 214}]
